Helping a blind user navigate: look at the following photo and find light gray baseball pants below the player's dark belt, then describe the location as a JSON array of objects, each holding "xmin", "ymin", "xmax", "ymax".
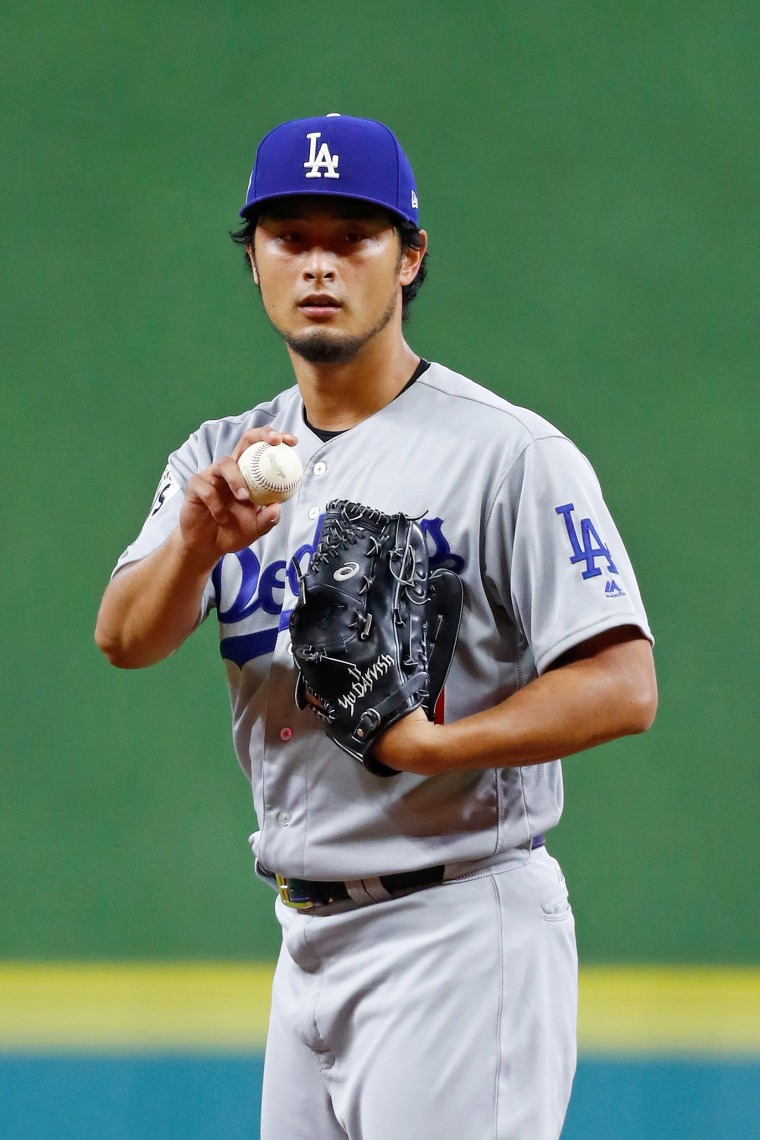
[{"xmin": 261, "ymin": 847, "xmax": 578, "ymax": 1140}]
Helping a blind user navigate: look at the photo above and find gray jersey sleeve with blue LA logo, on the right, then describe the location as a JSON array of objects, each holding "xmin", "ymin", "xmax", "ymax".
[{"xmin": 485, "ymin": 435, "xmax": 653, "ymax": 674}]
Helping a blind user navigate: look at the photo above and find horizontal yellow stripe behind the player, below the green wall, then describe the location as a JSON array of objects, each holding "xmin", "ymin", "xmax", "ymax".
[{"xmin": 0, "ymin": 962, "xmax": 760, "ymax": 1057}]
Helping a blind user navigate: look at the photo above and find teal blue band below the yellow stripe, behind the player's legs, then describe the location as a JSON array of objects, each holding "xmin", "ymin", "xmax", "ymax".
[{"xmin": 0, "ymin": 1056, "xmax": 760, "ymax": 1140}]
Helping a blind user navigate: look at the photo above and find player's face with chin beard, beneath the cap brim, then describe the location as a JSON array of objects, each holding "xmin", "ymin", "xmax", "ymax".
[{"xmin": 251, "ymin": 196, "xmax": 420, "ymax": 364}]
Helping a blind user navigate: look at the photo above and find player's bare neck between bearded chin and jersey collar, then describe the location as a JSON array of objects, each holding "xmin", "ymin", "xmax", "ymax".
[{"xmin": 288, "ymin": 335, "xmax": 419, "ymax": 431}]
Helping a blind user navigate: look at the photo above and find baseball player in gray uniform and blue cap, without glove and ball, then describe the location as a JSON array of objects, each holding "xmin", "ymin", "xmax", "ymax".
[{"xmin": 96, "ymin": 115, "xmax": 656, "ymax": 1140}]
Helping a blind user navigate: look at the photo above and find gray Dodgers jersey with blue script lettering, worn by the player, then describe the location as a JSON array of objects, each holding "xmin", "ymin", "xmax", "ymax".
[{"xmin": 117, "ymin": 364, "xmax": 651, "ymax": 880}]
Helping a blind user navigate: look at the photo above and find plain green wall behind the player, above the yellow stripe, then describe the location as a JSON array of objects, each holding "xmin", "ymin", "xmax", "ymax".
[{"xmin": 0, "ymin": 0, "xmax": 760, "ymax": 962}]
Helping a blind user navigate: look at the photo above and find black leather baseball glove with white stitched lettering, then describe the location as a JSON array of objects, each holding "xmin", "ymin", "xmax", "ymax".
[{"xmin": 291, "ymin": 499, "xmax": 463, "ymax": 776}]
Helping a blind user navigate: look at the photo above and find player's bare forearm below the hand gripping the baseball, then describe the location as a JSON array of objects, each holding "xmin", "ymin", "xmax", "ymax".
[{"xmin": 95, "ymin": 528, "xmax": 214, "ymax": 669}]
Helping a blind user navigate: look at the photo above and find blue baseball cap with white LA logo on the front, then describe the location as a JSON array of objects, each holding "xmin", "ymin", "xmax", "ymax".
[{"xmin": 240, "ymin": 114, "xmax": 418, "ymax": 226}]
